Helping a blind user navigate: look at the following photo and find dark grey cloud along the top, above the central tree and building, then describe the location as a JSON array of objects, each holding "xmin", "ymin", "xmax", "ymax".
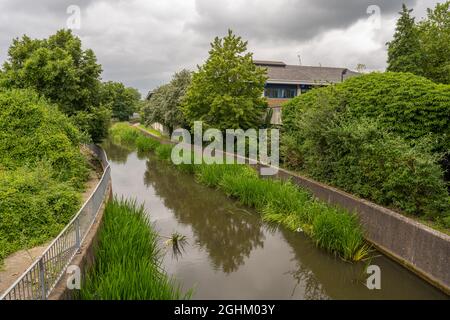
[{"xmin": 189, "ymin": 0, "xmax": 416, "ymax": 41}]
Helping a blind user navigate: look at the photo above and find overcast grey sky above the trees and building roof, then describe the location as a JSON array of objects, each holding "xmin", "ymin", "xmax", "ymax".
[{"xmin": 0, "ymin": 0, "xmax": 441, "ymax": 94}]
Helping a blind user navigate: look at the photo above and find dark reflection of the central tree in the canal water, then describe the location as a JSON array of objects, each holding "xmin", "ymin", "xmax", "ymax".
[{"xmin": 144, "ymin": 157, "xmax": 264, "ymax": 273}]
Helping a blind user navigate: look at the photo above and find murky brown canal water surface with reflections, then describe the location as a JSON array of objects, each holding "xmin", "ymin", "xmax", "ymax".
[{"xmin": 104, "ymin": 141, "xmax": 447, "ymax": 299}]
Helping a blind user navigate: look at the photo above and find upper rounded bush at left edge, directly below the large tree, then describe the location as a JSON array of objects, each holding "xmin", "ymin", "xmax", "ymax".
[{"xmin": 0, "ymin": 90, "xmax": 88, "ymax": 187}]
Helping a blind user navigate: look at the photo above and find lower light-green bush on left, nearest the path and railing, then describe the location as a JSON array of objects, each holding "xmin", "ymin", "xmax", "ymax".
[{"xmin": 0, "ymin": 162, "xmax": 80, "ymax": 261}]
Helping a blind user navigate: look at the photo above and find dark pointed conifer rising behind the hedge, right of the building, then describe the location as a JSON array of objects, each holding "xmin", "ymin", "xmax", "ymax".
[{"xmin": 387, "ymin": 4, "xmax": 422, "ymax": 74}]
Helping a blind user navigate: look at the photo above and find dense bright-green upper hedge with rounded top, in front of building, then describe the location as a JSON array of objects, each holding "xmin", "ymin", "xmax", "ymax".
[{"xmin": 283, "ymin": 72, "xmax": 450, "ymax": 152}]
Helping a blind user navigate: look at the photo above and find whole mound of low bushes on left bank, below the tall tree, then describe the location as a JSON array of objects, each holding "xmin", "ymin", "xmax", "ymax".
[{"xmin": 0, "ymin": 89, "xmax": 89, "ymax": 261}]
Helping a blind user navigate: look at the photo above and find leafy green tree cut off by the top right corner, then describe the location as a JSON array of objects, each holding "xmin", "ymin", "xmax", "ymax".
[{"xmin": 418, "ymin": 1, "xmax": 450, "ymax": 84}]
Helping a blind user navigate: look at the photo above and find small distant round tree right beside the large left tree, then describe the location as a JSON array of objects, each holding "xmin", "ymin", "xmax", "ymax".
[{"xmin": 100, "ymin": 81, "xmax": 141, "ymax": 121}]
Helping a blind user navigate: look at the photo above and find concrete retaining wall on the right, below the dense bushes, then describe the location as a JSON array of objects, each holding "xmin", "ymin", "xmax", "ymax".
[{"xmin": 277, "ymin": 169, "xmax": 450, "ymax": 294}]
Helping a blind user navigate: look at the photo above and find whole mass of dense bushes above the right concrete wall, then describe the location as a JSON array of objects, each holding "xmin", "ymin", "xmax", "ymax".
[{"xmin": 281, "ymin": 73, "xmax": 450, "ymax": 221}]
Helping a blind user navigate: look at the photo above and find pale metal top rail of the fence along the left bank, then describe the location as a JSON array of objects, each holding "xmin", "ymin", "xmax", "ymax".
[{"xmin": 0, "ymin": 145, "xmax": 111, "ymax": 300}]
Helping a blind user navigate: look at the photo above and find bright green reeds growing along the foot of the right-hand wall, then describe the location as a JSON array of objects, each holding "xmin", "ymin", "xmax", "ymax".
[{"xmin": 108, "ymin": 124, "xmax": 369, "ymax": 261}]
